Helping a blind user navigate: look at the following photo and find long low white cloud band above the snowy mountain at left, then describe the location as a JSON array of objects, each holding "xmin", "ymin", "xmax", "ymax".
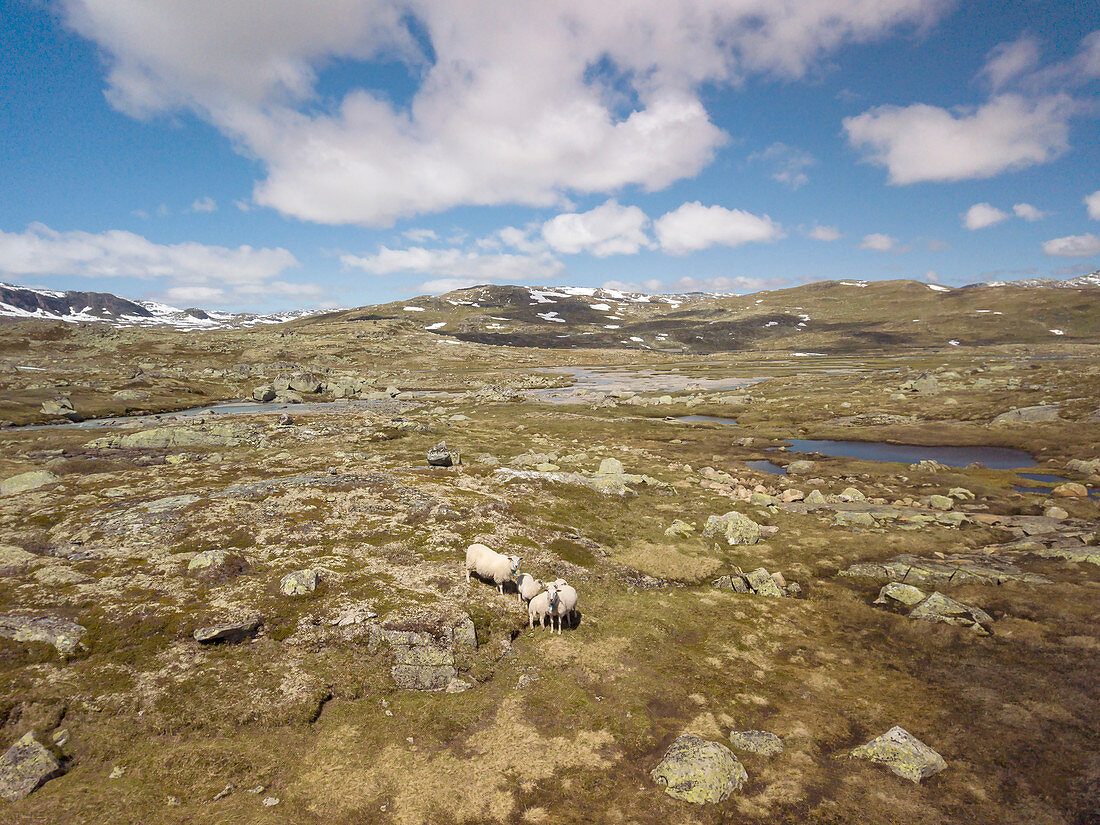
[{"xmin": 0, "ymin": 223, "xmax": 301, "ymax": 308}]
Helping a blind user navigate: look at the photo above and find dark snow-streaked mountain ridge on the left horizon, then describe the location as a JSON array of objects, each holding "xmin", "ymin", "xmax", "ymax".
[{"xmin": 0, "ymin": 283, "xmax": 318, "ymax": 330}]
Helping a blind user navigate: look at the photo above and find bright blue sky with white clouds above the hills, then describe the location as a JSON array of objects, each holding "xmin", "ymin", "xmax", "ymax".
[{"xmin": 0, "ymin": 0, "xmax": 1100, "ymax": 310}]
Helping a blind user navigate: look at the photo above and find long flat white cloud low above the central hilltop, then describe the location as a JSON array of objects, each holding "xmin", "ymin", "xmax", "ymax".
[{"xmin": 340, "ymin": 246, "xmax": 564, "ymax": 283}]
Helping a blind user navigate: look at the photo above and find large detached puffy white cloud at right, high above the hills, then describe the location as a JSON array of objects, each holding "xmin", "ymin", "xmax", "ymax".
[{"xmin": 844, "ymin": 95, "xmax": 1077, "ymax": 184}]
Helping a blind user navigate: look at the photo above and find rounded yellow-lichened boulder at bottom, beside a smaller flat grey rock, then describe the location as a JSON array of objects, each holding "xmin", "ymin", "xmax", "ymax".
[{"xmin": 649, "ymin": 734, "xmax": 748, "ymax": 805}]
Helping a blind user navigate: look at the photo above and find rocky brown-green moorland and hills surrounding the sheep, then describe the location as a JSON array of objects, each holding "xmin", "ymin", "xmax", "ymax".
[{"xmin": 0, "ymin": 282, "xmax": 1100, "ymax": 825}]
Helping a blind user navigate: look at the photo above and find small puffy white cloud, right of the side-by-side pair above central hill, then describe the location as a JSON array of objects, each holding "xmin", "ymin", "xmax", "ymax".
[{"xmin": 653, "ymin": 200, "xmax": 783, "ymax": 255}]
